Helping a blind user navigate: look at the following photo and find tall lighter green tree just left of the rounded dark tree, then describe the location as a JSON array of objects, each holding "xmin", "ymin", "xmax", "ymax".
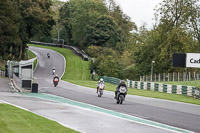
[{"xmin": 60, "ymin": 0, "xmax": 107, "ymax": 48}]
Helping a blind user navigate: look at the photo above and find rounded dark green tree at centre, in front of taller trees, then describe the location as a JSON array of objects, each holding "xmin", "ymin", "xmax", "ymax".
[{"xmin": 86, "ymin": 15, "xmax": 121, "ymax": 46}]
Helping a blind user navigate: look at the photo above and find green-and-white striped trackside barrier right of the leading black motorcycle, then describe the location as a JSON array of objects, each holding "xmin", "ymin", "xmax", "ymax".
[{"xmin": 127, "ymin": 80, "xmax": 196, "ymax": 96}]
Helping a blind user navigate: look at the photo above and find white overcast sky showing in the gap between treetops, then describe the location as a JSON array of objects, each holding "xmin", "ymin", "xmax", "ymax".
[{"xmin": 61, "ymin": 0, "xmax": 162, "ymax": 28}]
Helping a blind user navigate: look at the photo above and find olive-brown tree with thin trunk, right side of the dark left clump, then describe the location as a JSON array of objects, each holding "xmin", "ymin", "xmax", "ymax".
[{"xmin": 13, "ymin": 0, "xmax": 55, "ymax": 59}]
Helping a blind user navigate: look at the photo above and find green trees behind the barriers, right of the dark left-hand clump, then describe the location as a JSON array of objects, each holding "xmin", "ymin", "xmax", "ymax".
[{"xmin": 58, "ymin": 0, "xmax": 200, "ymax": 79}]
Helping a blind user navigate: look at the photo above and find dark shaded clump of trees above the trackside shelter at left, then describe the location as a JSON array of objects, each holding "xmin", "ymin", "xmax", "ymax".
[{"xmin": 0, "ymin": 0, "xmax": 55, "ymax": 60}]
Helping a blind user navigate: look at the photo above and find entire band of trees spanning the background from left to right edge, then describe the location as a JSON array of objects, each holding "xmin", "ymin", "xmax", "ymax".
[{"xmin": 0, "ymin": 0, "xmax": 200, "ymax": 80}]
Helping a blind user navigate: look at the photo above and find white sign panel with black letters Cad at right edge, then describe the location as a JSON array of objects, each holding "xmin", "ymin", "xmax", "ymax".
[{"xmin": 186, "ymin": 53, "xmax": 200, "ymax": 68}]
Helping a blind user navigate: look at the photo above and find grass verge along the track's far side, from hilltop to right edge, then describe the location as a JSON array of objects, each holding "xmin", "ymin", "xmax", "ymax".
[{"xmin": 29, "ymin": 45, "xmax": 200, "ymax": 105}]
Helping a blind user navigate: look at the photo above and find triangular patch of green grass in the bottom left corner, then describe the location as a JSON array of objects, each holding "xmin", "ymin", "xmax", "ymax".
[{"xmin": 0, "ymin": 104, "xmax": 79, "ymax": 133}]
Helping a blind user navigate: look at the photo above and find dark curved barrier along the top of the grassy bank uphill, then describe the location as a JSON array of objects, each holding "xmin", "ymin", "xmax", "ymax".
[{"xmin": 30, "ymin": 41, "xmax": 89, "ymax": 61}]
